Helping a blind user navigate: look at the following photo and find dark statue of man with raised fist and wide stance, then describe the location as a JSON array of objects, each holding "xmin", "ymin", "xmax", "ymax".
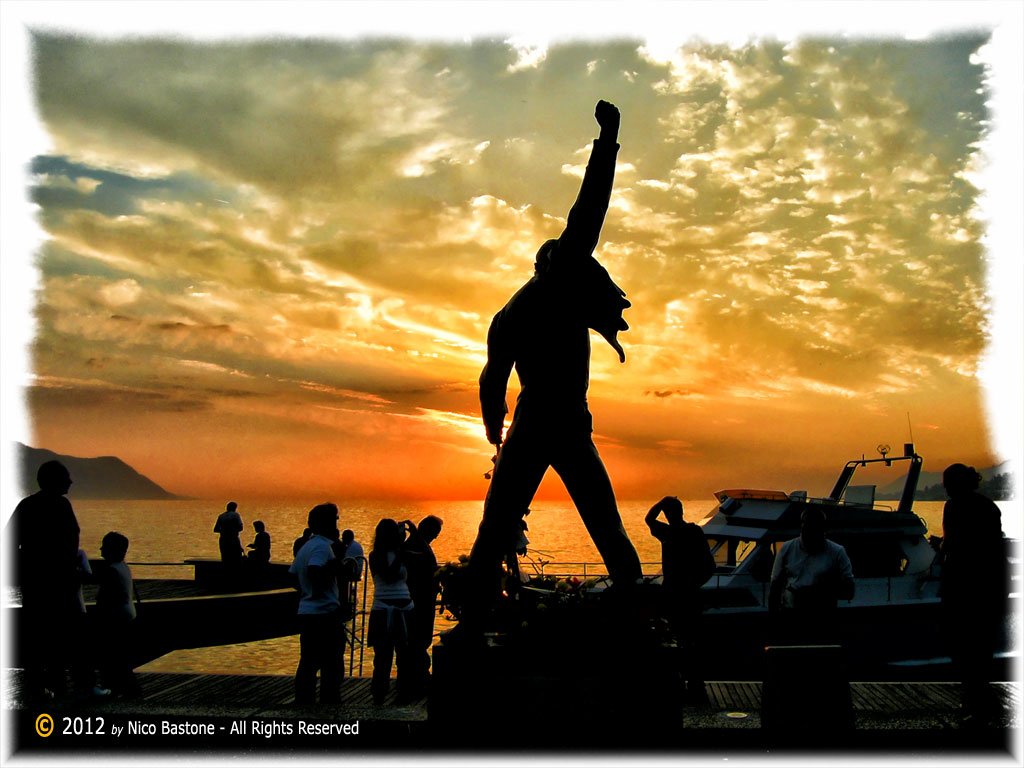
[{"xmin": 465, "ymin": 100, "xmax": 641, "ymax": 618}]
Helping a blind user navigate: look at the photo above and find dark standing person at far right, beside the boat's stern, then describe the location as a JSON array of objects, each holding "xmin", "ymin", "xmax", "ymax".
[{"xmin": 939, "ymin": 464, "xmax": 1009, "ymax": 722}]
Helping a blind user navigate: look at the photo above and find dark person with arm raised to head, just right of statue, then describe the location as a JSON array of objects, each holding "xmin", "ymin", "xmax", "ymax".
[{"xmin": 644, "ymin": 496, "xmax": 715, "ymax": 705}]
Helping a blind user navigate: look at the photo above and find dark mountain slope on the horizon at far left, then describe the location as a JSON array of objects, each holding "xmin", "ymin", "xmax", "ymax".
[{"xmin": 17, "ymin": 442, "xmax": 183, "ymax": 500}]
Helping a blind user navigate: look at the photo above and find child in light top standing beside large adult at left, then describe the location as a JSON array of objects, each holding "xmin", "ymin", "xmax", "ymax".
[{"xmin": 96, "ymin": 530, "xmax": 139, "ymax": 695}]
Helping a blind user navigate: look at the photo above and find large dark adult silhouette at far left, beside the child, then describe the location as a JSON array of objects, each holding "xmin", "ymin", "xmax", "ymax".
[{"xmin": 9, "ymin": 461, "xmax": 100, "ymax": 701}]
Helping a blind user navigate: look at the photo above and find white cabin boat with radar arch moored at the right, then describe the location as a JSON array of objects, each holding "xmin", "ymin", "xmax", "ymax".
[{"xmin": 699, "ymin": 443, "xmax": 1020, "ymax": 679}]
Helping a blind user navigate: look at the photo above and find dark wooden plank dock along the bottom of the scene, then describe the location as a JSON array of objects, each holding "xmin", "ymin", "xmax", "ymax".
[{"xmin": 3, "ymin": 671, "xmax": 1022, "ymax": 764}]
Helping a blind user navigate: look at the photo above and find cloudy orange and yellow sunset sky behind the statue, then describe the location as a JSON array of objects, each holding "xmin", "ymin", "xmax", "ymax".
[{"xmin": 4, "ymin": 3, "xmax": 1020, "ymax": 499}]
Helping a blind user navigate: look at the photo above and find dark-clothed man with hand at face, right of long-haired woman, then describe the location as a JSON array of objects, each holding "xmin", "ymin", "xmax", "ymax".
[{"xmin": 402, "ymin": 515, "xmax": 443, "ymax": 698}]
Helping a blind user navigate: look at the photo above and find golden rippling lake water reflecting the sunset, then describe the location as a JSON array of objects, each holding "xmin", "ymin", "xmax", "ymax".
[{"xmin": 73, "ymin": 498, "xmax": 1022, "ymax": 675}]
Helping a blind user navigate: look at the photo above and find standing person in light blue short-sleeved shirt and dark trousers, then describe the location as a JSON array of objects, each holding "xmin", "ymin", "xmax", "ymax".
[{"xmin": 289, "ymin": 504, "xmax": 345, "ymax": 705}]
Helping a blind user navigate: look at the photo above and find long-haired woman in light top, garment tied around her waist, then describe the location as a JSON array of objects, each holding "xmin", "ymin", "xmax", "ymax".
[{"xmin": 367, "ymin": 517, "xmax": 413, "ymax": 705}]
